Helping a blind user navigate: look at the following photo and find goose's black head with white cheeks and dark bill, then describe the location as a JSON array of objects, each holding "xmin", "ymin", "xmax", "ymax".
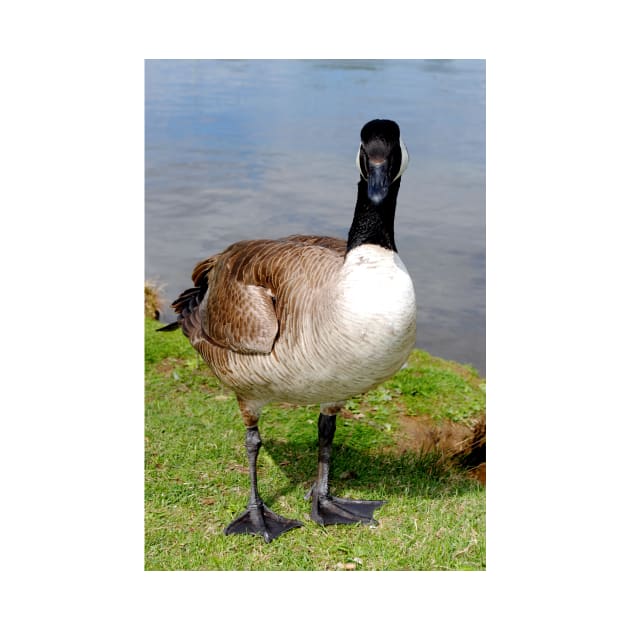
[{"xmin": 357, "ymin": 119, "xmax": 409, "ymax": 205}]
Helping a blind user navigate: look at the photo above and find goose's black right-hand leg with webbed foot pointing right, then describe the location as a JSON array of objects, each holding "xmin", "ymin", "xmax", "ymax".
[{"xmin": 307, "ymin": 413, "xmax": 385, "ymax": 525}]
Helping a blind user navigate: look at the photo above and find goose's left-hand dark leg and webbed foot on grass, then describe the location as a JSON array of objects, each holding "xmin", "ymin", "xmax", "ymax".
[{"xmin": 225, "ymin": 426, "xmax": 302, "ymax": 542}]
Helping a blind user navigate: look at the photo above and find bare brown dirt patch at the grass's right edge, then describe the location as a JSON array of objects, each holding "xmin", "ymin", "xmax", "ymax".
[{"xmin": 394, "ymin": 414, "xmax": 486, "ymax": 485}]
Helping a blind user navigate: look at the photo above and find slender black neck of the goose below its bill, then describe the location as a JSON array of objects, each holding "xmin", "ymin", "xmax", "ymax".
[{"xmin": 346, "ymin": 179, "xmax": 400, "ymax": 254}]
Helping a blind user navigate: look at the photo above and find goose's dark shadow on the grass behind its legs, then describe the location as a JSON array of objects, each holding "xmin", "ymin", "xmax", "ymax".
[{"xmin": 263, "ymin": 438, "xmax": 479, "ymax": 500}]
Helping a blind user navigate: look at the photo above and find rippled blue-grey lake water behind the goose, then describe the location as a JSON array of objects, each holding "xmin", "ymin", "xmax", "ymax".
[{"xmin": 145, "ymin": 60, "xmax": 486, "ymax": 374}]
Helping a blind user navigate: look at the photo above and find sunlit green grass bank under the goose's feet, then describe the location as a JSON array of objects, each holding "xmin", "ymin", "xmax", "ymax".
[{"xmin": 145, "ymin": 320, "xmax": 485, "ymax": 571}]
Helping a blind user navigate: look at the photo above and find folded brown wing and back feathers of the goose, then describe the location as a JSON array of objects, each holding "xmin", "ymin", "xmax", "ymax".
[{"xmin": 173, "ymin": 235, "xmax": 346, "ymax": 360}]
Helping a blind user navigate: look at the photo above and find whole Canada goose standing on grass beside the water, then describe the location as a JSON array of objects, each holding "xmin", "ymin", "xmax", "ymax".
[{"xmin": 162, "ymin": 120, "xmax": 416, "ymax": 542}]
